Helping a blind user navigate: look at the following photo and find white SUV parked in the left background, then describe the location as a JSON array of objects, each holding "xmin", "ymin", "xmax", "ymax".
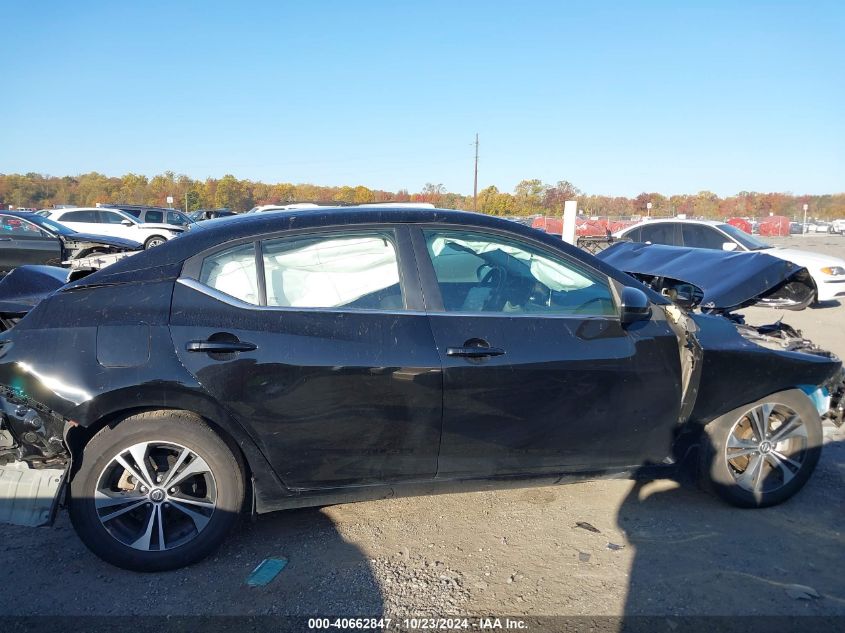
[{"xmin": 43, "ymin": 207, "xmax": 185, "ymax": 248}]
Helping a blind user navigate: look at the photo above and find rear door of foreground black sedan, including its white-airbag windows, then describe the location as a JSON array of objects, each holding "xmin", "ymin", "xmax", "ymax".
[{"xmin": 170, "ymin": 226, "xmax": 442, "ymax": 488}]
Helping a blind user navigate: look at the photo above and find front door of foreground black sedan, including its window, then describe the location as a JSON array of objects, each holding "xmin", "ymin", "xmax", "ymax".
[{"xmin": 415, "ymin": 228, "xmax": 681, "ymax": 478}]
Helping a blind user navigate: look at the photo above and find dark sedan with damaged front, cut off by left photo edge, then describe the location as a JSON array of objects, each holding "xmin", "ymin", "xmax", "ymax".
[{"xmin": 0, "ymin": 211, "xmax": 143, "ymax": 275}]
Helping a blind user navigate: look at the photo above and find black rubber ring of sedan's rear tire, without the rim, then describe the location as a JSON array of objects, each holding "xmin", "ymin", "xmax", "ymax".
[{"xmin": 68, "ymin": 416, "xmax": 244, "ymax": 571}]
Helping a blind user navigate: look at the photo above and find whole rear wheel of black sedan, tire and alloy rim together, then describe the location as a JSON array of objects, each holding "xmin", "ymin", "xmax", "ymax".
[{"xmin": 68, "ymin": 411, "xmax": 244, "ymax": 572}]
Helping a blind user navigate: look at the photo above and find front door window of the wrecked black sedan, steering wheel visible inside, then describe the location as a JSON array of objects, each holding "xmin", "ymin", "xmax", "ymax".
[{"xmin": 424, "ymin": 230, "xmax": 616, "ymax": 316}]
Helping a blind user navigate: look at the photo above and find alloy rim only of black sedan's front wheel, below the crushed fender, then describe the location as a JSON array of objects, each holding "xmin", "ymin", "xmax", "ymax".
[{"xmin": 724, "ymin": 403, "xmax": 808, "ymax": 495}]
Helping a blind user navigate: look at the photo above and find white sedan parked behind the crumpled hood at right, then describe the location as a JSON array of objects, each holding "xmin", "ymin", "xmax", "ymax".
[{"xmin": 614, "ymin": 219, "xmax": 845, "ymax": 301}]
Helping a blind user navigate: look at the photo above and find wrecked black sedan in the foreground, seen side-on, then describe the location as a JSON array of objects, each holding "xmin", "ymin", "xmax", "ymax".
[{"xmin": 0, "ymin": 208, "xmax": 841, "ymax": 570}]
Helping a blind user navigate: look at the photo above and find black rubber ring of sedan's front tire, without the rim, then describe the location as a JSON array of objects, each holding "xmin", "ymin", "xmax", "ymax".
[{"xmin": 701, "ymin": 390, "xmax": 823, "ymax": 508}]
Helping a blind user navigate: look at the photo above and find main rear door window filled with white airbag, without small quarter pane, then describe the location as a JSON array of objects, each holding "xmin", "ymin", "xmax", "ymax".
[{"xmin": 262, "ymin": 232, "xmax": 405, "ymax": 310}]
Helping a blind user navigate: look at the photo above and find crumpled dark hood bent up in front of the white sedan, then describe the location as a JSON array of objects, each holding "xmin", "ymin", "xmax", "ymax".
[{"xmin": 596, "ymin": 242, "xmax": 814, "ymax": 312}]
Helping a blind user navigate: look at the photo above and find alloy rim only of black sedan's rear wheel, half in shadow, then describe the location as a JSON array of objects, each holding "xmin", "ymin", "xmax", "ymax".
[{"xmin": 94, "ymin": 441, "xmax": 217, "ymax": 551}]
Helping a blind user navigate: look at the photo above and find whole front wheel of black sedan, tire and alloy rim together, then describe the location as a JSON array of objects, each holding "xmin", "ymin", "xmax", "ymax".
[{"xmin": 699, "ymin": 390, "xmax": 822, "ymax": 508}]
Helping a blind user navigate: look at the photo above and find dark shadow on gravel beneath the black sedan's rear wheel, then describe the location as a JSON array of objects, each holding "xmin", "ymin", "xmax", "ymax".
[{"xmin": 0, "ymin": 508, "xmax": 384, "ymax": 617}]
